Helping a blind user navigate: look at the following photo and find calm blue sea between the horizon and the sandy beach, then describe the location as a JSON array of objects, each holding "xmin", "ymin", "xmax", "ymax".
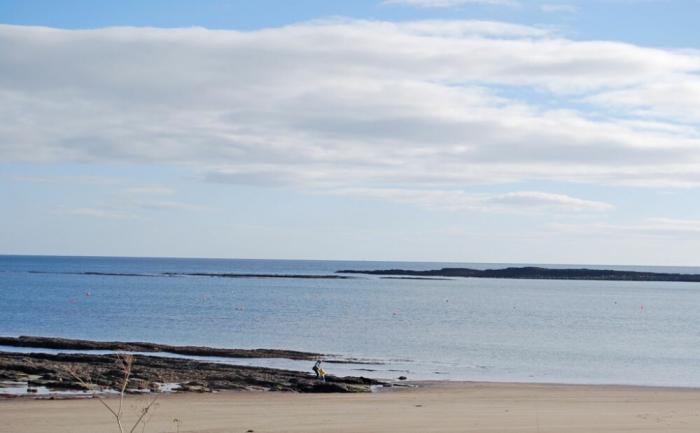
[{"xmin": 0, "ymin": 256, "xmax": 700, "ymax": 387}]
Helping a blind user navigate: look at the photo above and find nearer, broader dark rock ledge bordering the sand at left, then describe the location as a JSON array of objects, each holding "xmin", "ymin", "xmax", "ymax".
[{"xmin": 0, "ymin": 352, "xmax": 382, "ymax": 392}]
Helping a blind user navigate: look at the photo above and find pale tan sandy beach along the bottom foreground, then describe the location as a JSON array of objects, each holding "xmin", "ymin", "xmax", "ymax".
[{"xmin": 0, "ymin": 383, "xmax": 700, "ymax": 433}]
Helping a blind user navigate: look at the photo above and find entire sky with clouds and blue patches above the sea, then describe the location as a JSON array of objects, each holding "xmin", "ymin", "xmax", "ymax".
[{"xmin": 0, "ymin": 0, "xmax": 700, "ymax": 266}]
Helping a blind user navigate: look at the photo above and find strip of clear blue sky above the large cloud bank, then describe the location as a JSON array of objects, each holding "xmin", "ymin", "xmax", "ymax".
[{"xmin": 5, "ymin": 0, "xmax": 700, "ymax": 47}]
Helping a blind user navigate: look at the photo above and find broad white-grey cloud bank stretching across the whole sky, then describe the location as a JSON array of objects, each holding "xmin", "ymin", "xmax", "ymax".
[{"xmin": 0, "ymin": 20, "xmax": 700, "ymax": 210}]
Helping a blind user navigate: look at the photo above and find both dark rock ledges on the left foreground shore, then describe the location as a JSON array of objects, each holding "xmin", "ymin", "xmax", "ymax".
[{"xmin": 0, "ymin": 337, "xmax": 385, "ymax": 396}]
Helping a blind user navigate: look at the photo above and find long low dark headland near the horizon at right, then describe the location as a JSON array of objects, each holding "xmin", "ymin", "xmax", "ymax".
[{"xmin": 337, "ymin": 266, "xmax": 700, "ymax": 283}]
